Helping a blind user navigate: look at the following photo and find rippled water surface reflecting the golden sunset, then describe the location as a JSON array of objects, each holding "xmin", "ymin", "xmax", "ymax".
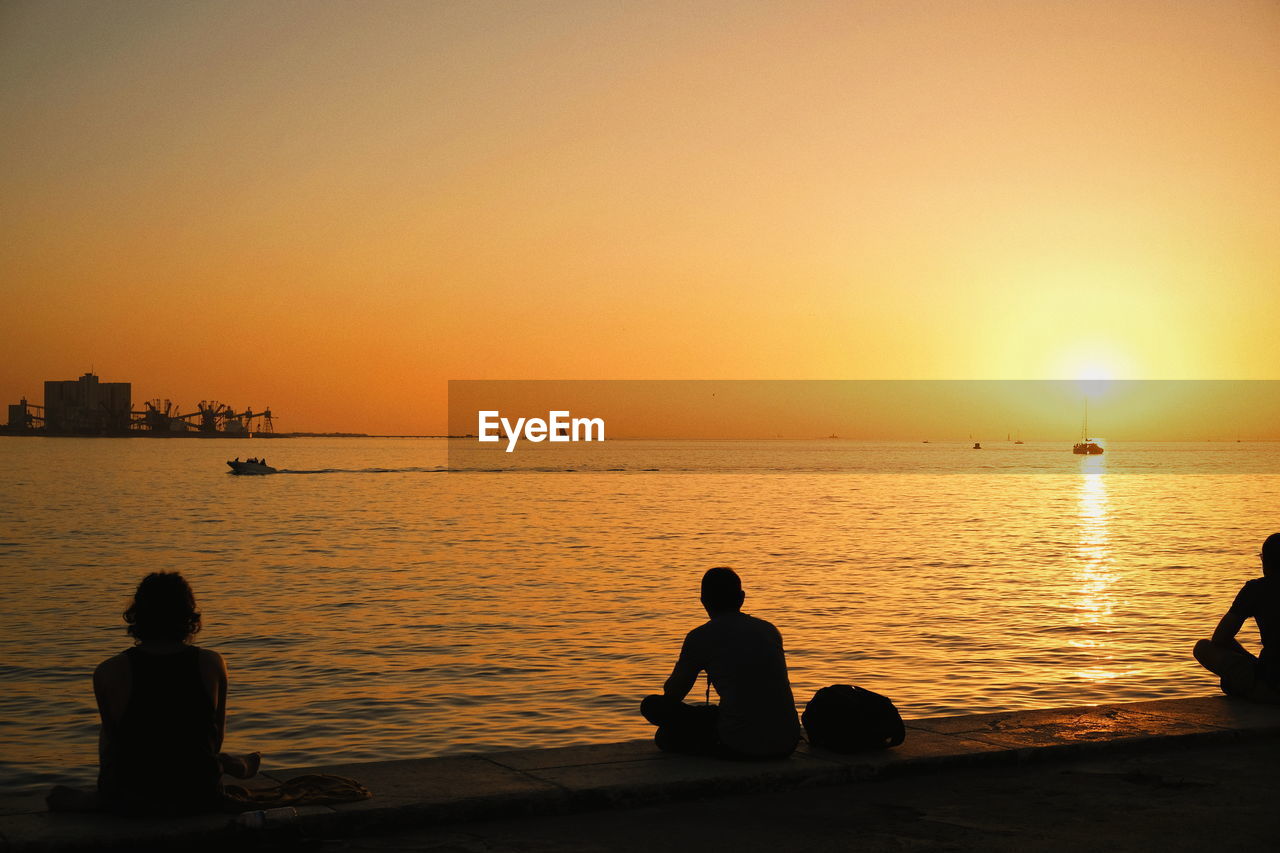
[{"xmin": 0, "ymin": 438, "xmax": 1280, "ymax": 789}]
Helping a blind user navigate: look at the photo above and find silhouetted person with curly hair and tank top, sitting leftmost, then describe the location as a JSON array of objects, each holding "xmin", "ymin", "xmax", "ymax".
[{"xmin": 62, "ymin": 573, "xmax": 260, "ymax": 815}]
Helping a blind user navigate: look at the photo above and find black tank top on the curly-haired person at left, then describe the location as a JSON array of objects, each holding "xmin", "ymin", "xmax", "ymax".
[{"xmin": 99, "ymin": 646, "xmax": 221, "ymax": 813}]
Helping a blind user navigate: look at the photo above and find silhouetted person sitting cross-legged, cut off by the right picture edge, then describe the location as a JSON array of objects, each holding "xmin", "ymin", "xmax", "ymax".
[{"xmin": 1194, "ymin": 533, "xmax": 1280, "ymax": 703}]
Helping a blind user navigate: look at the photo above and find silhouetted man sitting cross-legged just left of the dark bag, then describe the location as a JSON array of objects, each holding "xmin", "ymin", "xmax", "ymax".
[{"xmin": 640, "ymin": 566, "xmax": 800, "ymax": 758}]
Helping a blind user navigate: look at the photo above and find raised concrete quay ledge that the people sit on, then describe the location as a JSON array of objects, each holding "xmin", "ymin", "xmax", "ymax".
[{"xmin": 0, "ymin": 695, "xmax": 1280, "ymax": 850}]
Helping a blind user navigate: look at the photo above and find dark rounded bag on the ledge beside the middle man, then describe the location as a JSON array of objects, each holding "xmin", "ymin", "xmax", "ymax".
[{"xmin": 800, "ymin": 684, "xmax": 906, "ymax": 752}]
